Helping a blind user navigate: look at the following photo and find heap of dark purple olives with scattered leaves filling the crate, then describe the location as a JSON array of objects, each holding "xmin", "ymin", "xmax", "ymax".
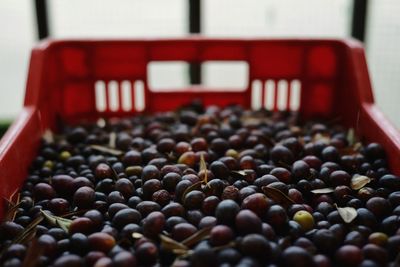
[{"xmin": 0, "ymin": 101, "xmax": 400, "ymax": 267}]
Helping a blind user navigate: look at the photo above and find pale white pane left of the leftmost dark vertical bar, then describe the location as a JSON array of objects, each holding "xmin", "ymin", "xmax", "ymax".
[{"xmin": 0, "ymin": 0, "xmax": 36, "ymax": 119}]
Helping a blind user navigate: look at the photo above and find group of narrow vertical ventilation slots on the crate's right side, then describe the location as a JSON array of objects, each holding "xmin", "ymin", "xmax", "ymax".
[{"xmin": 251, "ymin": 79, "xmax": 301, "ymax": 111}]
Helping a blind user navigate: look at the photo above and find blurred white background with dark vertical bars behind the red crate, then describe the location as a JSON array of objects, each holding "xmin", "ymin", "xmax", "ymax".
[{"xmin": 0, "ymin": 0, "xmax": 400, "ymax": 134}]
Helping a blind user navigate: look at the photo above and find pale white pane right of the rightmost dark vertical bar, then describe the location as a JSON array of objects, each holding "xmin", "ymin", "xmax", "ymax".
[{"xmin": 367, "ymin": 0, "xmax": 400, "ymax": 129}]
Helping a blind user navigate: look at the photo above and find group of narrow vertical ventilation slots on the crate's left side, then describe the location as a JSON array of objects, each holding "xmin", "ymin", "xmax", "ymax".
[{"xmin": 94, "ymin": 80, "xmax": 145, "ymax": 112}]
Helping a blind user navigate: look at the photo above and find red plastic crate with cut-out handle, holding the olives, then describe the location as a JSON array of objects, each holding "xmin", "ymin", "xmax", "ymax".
[{"xmin": 0, "ymin": 38, "xmax": 400, "ymax": 217}]
